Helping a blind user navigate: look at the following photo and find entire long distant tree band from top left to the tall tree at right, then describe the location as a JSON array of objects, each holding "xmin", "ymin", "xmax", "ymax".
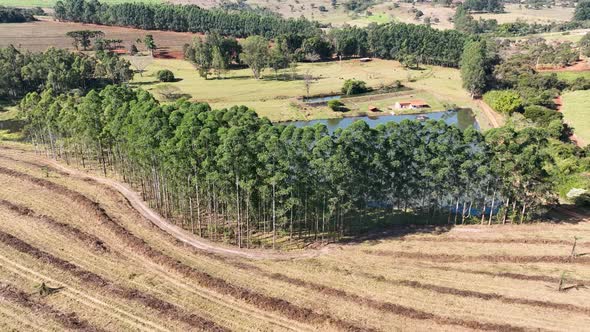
[{"xmin": 55, "ymin": 0, "xmax": 466, "ymax": 67}]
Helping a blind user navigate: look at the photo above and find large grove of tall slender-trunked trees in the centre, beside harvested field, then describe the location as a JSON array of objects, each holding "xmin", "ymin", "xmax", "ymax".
[{"xmin": 20, "ymin": 85, "xmax": 553, "ymax": 246}]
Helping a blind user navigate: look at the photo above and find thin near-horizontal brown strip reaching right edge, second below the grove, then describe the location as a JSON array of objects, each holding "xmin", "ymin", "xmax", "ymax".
[{"xmin": 363, "ymin": 250, "xmax": 590, "ymax": 264}]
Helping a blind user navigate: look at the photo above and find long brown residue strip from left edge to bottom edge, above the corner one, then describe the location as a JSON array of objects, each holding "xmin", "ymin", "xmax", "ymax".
[{"xmin": 0, "ymin": 231, "xmax": 228, "ymax": 331}]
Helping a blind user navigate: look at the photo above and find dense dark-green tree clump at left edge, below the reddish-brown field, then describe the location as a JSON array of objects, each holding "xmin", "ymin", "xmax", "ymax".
[{"xmin": 0, "ymin": 46, "xmax": 133, "ymax": 99}]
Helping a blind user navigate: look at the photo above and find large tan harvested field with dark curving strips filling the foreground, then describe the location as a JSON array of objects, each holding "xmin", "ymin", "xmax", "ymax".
[{"xmin": 0, "ymin": 143, "xmax": 590, "ymax": 331}]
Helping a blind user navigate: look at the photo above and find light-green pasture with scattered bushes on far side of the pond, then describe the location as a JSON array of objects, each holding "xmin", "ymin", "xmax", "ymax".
[{"xmin": 134, "ymin": 60, "xmax": 485, "ymax": 126}]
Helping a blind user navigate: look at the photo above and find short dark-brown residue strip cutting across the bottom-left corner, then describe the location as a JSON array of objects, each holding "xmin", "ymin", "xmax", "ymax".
[{"xmin": 0, "ymin": 282, "xmax": 105, "ymax": 332}]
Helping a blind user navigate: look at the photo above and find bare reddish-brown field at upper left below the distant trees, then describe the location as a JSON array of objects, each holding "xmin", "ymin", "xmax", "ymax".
[{"xmin": 0, "ymin": 19, "xmax": 197, "ymax": 54}]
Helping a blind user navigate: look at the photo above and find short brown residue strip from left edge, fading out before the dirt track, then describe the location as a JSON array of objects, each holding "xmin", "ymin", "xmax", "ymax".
[{"xmin": 0, "ymin": 199, "xmax": 109, "ymax": 253}]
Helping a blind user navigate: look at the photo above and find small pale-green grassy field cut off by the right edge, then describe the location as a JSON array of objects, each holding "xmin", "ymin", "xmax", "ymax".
[{"xmin": 562, "ymin": 91, "xmax": 590, "ymax": 144}]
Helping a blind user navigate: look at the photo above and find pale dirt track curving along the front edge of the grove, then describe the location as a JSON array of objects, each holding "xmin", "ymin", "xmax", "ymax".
[{"xmin": 48, "ymin": 160, "xmax": 328, "ymax": 260}]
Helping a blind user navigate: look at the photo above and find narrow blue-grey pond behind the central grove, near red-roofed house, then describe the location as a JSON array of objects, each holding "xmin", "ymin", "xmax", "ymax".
[{"xmin": 279, "ymin": 108, "xmax": 480, "ymax": 133}]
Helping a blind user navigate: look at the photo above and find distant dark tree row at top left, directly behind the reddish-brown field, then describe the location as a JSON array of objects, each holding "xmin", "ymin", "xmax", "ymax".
[{"xmin": 55, "ymin": 0, "xmax": 319, "ymax": 38}]
